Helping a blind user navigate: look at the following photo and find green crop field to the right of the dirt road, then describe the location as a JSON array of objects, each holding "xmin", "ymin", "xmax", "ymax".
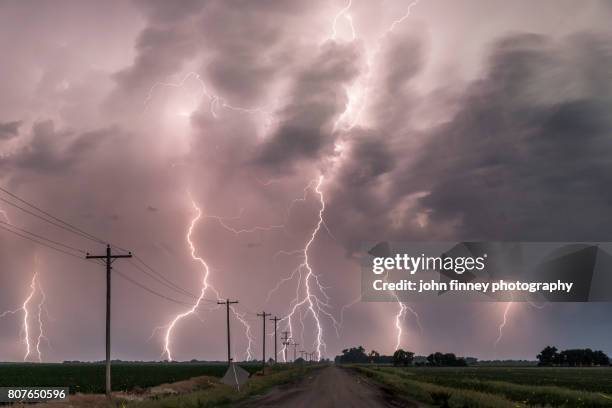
[{"xmin": 355, "ymin": 366, "xmax": 612, "ymax": 408}]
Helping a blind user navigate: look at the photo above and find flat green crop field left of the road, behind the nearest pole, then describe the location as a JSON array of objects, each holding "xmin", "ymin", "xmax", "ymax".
[{"xmin": 0, "ymin": 363, "xmax": 261, "ymax": 393}]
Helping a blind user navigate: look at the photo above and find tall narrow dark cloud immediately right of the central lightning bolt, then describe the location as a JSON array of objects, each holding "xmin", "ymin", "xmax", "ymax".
[{"xmin": 327, "ymin": 33, "xmax": 427, "ymax": 252}]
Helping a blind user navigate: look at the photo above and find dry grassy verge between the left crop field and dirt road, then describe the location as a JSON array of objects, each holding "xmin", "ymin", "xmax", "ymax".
[{"xmin": 124, "ymin": 367, "xmax": 314, "ymax": 408}]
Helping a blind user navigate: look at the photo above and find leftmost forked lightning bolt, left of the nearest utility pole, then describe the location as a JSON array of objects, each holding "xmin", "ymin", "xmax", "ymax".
[{"xmin": 0, "ymin": 257, "xmax": 49, "ymax": 362}]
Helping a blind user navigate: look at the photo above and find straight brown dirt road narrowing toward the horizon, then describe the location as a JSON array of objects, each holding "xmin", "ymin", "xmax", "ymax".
[{"xmin": 240, "ymin": 366, "xmax": 418, "ymax": 408}]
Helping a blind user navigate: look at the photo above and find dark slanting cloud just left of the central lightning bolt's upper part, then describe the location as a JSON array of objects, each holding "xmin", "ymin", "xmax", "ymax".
[{"xmin": 258, "ymin": 42, "xmax": 359, "ymax": 168}]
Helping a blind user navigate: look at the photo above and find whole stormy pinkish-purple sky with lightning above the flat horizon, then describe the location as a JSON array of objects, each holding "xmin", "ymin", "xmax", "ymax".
[{"xmin": 0, "ymin": 0, "xmax": 612, "ymax": 361}]
